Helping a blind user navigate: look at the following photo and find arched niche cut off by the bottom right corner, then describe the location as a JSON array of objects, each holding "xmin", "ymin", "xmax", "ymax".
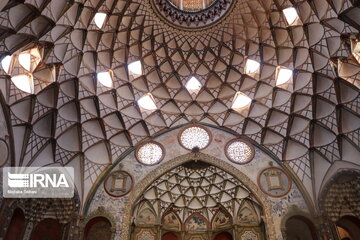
[{"xmin": 336, "ymin": 216, "xmax": 360, "ymax": 240}]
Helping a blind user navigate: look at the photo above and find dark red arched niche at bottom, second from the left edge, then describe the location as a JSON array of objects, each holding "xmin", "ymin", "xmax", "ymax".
[{"xmin": 30, "ymin": 218, "xmax": 64, "ymax": 240}]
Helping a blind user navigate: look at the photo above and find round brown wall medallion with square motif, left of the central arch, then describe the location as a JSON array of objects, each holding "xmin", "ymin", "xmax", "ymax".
[{"xmin": 104, "ymin": 170, "xmax": 134, "ymax": 197}]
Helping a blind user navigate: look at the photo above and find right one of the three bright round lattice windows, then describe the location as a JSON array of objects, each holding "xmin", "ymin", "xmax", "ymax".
[{"xmin": 225, "ymin": 139, "xmax": 255, "ymax": 164}]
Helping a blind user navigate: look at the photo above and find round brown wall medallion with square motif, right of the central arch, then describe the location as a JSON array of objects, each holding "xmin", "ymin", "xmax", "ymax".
[{"xmin": 258, "ymin": 167, "xmax": 291, "ymax": 197}]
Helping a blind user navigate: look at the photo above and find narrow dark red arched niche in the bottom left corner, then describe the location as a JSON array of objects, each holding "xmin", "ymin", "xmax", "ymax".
[{"xmin": 4, "ymin": 208, "xmax": 25, "ymax": 240}]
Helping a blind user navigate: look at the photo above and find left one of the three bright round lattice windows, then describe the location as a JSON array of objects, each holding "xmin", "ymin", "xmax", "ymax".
[{"xmin": 135, "ymin": 141, "xmax": 165, "ymax": 165}]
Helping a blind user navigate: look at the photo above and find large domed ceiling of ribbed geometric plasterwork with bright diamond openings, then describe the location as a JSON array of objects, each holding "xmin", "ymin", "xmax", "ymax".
[{"xmin": 0, "ymin": 0, "xmax": 360, "ymax": 206}]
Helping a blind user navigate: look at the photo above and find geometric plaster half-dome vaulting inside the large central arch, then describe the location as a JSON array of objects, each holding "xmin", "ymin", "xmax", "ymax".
[{"xmin": 138, "ymin": 162, "xmax": 261, "ymax": 223}]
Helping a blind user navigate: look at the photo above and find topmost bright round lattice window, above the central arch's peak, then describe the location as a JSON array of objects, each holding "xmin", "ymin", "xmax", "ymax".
[{"xmin": 179, "ymin": 125, "xmax": 211, "ymax": 150}]
